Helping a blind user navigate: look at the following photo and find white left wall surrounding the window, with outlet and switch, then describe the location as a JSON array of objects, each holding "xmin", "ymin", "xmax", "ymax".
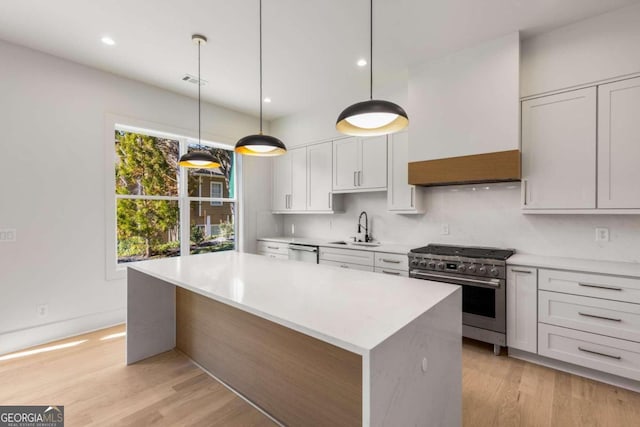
[{"xmin": 0, "ymin": 42, "xmax": 272, "ymax": 356}]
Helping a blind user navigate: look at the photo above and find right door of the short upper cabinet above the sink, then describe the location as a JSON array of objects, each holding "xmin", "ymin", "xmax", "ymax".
[{"xmin": 356, "ymin": 135, "xmax": 387, "ymax": 189}]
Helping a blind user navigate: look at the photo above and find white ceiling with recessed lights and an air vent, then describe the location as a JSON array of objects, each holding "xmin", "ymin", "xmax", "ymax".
[{"xmin": 0, "ymin": 0, "xmax": 640, "ymax": 118}]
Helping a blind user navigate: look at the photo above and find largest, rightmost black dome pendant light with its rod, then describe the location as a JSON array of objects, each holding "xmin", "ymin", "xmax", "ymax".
[{"xmin": 336, "ymin": 0, "xmax": 409, "ymax": 136}]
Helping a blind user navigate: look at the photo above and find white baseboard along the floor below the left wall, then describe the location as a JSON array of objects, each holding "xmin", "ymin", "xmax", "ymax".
[{"xmin": 0, "ymin": 308, "xmax": 127, "ymax": 355}]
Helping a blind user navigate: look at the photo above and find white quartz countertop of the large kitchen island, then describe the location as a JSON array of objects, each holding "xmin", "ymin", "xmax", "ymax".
[{"xmin": 129, "ymin": 251, "xmax": 459, "ymax": 354}]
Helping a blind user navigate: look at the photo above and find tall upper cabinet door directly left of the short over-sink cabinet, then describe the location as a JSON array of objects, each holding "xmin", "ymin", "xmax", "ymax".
[{"xmin": 307, "ymin": 142, "xmax": 332, "ymax": 211}]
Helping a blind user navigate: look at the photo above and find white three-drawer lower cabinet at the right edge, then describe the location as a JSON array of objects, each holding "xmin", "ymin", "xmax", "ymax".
[{"xmin": 538, "ymin": 269, "xmax": 640, "ymax": 380}]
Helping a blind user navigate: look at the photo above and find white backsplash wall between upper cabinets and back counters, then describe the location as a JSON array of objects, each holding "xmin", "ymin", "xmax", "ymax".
[{"xmin": 283, "ymin": 183, "xmax": 640, "ymax": 262}]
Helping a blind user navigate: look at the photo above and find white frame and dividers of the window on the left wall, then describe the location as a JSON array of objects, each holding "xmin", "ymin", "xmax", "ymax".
[{"xmin": 104, "ymin": 114, "xmax": 244, "ymax": 280}]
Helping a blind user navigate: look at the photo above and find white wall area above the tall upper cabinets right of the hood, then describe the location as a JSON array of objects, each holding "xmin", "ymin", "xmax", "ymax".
[{"xmin": 520, "ymin": 4, "xmax": 640, "ymax": 96}]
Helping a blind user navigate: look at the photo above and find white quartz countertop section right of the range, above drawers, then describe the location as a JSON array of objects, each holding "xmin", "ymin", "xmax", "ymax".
[{"xmin": 507, "ymin": 253, "xmax": 640, "ymax": 277}]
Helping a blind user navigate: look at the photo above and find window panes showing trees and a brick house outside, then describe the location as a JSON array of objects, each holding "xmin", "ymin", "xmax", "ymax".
[{"xmin": 111, "ymin": 125, "xmax": 237, "ymax": 274}]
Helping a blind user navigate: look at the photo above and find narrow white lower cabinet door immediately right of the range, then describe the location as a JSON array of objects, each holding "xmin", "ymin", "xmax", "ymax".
[{"xmin": 507, "ymin": 267, "xmax": 538, "ymax": 353}]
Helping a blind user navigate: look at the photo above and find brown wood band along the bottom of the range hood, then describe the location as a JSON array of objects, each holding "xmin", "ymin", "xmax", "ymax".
[{"xmin": 409, "ymin": 150, "xmax": 521, "ymax": 186}]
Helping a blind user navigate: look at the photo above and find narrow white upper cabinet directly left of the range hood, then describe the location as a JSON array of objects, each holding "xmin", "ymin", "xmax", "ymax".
[{"xmin": 387, "ymin": 132, "xmax": 423, "ymax": 213}]
